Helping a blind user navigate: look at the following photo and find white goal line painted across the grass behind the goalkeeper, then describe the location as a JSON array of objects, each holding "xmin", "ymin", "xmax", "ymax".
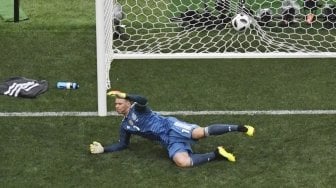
[{"xmin": 0, "ymin": 110, "xmax": 336, "ymax": 117}]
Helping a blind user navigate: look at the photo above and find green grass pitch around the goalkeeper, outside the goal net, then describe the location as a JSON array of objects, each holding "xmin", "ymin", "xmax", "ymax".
[{"xmin": 0, "ymin": 0, "xmax": 336, "ymax": 187}]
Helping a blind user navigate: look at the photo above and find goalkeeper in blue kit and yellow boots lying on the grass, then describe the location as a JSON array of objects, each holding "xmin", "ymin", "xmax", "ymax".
[{"xmin": 90, "ymin": 91, "xmax": 254, "ymax": 167}]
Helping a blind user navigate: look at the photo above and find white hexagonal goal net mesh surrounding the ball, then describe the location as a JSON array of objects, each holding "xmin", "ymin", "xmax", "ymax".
[{"xmin": 108, "ymin": 0, "xmax": 336, "ymax": 54}]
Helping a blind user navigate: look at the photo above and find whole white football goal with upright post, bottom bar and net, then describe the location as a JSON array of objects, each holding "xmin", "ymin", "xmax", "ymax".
[{"xmin": 96, "ymin": 0, "xmax": 336, "ymax": 116}]
